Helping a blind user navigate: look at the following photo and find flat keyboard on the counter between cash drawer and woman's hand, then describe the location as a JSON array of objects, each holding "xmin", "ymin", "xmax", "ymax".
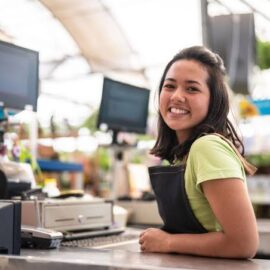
[{"xmin": 61, "ymin": 233, "xmax": 139, "ymax": 249}]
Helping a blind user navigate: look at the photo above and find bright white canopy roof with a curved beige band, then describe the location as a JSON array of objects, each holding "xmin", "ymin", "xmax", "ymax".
[{"xmin": 0, "ymin": 0, "xmax": 270, "ymax": 126}]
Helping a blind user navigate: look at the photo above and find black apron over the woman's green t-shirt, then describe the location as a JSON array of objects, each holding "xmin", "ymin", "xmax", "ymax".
[{"xmin": 148, "ymin": 166, "xmax": 207, "ymax": 233}]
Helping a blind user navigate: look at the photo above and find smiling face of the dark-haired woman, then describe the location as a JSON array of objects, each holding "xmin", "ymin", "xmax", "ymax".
[{"xmin": 159, "ymin": 59, "xmax": 210, "ymax": 142}]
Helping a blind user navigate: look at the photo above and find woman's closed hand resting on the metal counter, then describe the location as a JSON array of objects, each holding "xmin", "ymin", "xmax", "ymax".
[{"xmin": 139, "ymin": 228, "xmax": 170, "ymax": 253}]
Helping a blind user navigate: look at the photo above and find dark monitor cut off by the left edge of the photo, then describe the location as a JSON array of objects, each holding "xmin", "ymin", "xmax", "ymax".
[{"xmin": 0, "ymin": 41, "xmax": 39, "ymax": 111}]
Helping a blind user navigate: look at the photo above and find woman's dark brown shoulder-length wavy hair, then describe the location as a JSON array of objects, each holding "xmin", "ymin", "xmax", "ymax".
[{"xmin": 150, "ymin": 46, "xmax": 244, "ymax": 163}]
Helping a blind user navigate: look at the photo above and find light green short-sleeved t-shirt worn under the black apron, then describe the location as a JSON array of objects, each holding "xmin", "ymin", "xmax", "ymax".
[{"xmin": 185, "ymin": 135, "xmax": 246, "ymax": 231}]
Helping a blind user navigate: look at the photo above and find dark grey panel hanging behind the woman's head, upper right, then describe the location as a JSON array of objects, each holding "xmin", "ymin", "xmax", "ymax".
[{"xmin": 209, "ymin": 13, "xmax": 256, "ymax": 95}]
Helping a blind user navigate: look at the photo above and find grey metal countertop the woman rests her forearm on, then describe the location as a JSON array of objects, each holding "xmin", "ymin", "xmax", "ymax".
[{"xmin": 0, "ymin": 241, "xmax": 270, "ymax": 270}]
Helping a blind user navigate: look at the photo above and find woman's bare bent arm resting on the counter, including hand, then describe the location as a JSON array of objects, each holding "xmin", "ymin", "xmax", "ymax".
[{"xmin": 139, "ymin": 179, "xmax": 258, "ymax": 258}]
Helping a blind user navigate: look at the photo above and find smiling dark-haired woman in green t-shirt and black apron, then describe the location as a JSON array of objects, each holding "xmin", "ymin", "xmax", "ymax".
[{"xmin": 139, "ymin": 46, "xmax": 258, "ymax": 258}]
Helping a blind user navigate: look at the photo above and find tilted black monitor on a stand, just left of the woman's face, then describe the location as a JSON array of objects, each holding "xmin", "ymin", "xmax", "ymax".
[{"xmin": 97, "ymin": 78, "xmax": 150, "ymax": 133}]
